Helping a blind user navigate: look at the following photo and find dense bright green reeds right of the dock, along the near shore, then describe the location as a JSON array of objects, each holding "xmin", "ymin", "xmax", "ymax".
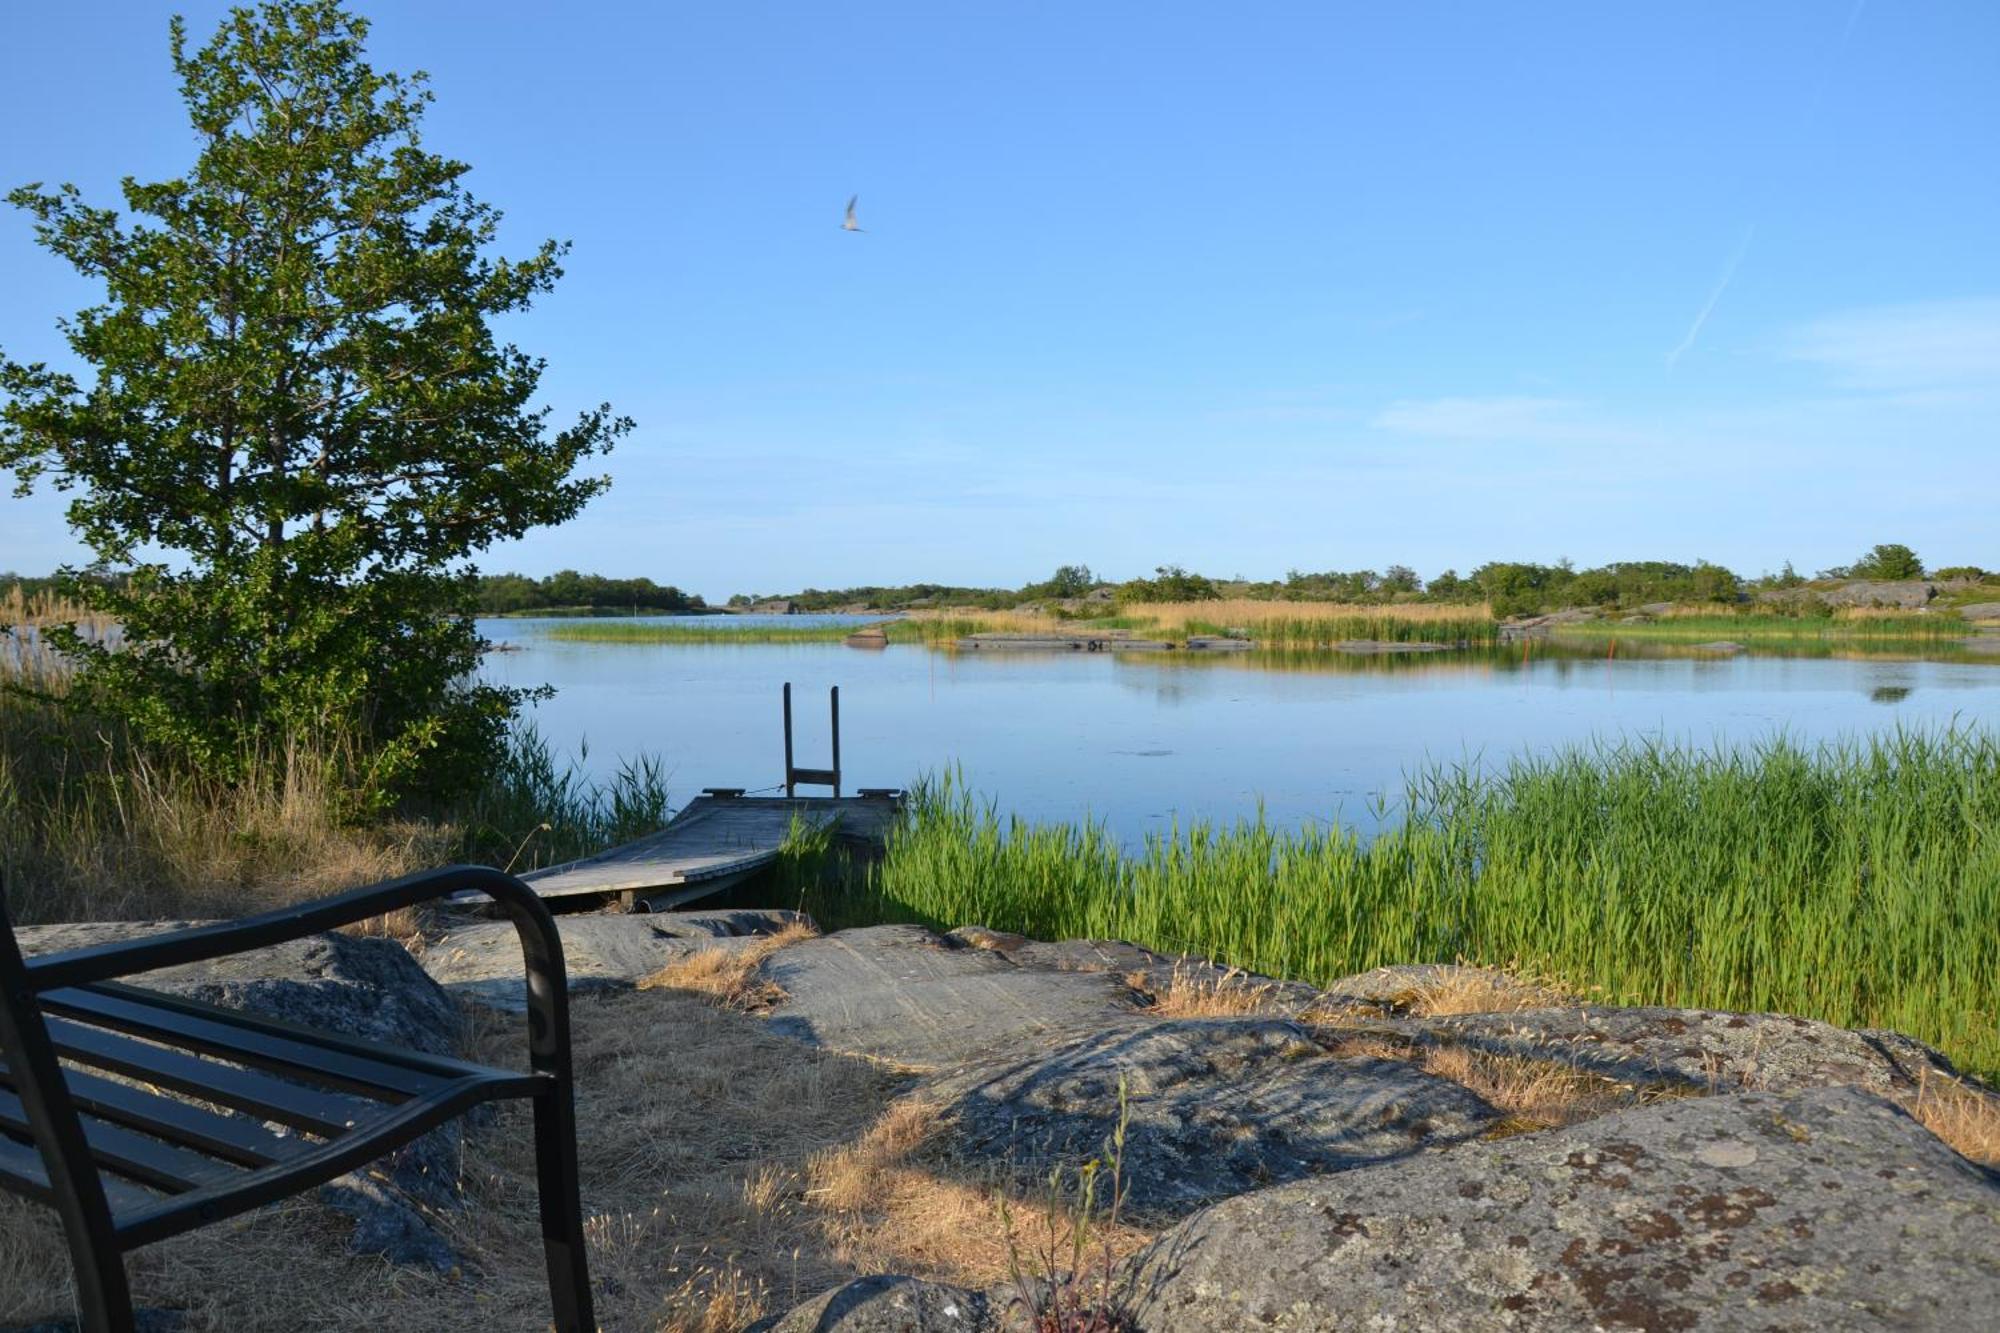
[{"xmin": 818, "ymin": 731, "xmax": 2000, "ymax": 1075}]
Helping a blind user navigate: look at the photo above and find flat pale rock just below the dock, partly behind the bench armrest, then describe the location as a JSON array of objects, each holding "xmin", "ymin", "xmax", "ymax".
[{"xmin": 422, "ymin": 913, "xmax": 772, "ymax": 1013}]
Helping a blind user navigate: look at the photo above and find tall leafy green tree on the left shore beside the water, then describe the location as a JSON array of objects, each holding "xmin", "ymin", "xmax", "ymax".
[{"xmin": 0, "ymin": 0, "xmax": 630, "ymax": 795}]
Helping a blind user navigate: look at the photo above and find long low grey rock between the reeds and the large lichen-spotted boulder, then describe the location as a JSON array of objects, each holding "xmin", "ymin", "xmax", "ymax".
[{"xmin": 1406, "ymin": 1005, "xmax": 1956, "ymax": 1097}]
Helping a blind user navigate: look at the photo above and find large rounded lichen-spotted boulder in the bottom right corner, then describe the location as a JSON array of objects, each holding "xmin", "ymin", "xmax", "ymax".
[{"xmin": 1126, "ymin": 1089, "xmax": 2000, "ymax": 1333}]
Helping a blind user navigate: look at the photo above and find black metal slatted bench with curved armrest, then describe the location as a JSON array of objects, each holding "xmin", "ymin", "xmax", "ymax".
[{"xmin": 0, "ymin": 867, "xmax": 596, "ymax": 1333}]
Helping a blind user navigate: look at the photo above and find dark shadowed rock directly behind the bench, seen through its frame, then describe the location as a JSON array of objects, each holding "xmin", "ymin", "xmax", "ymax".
[{"xmin": 16, "ymin": 921, "xmax": 464, "ymax": 1271}]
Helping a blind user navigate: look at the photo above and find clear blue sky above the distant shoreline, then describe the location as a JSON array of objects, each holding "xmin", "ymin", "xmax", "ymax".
[{"xmin": 0, "ymin": 0, "xmax": 2000, "ymax": 596}]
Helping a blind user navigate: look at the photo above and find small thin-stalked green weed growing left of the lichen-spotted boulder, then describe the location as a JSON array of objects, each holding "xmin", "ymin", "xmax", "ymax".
[{"xmin": 994, "ymin": 1075, "xmax": 1138, "ymax": 1333}]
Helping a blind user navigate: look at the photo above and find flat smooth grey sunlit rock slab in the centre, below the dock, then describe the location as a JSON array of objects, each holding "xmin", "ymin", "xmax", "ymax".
[{"xmin": 760, "ymin": 927, "xmax": 1138, "ymax": 1069}]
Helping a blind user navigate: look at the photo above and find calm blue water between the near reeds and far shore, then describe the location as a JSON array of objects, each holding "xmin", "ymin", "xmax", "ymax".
[{"xmin": 482, "ymin": 616, "xmax": 2000, "ymax": 839}]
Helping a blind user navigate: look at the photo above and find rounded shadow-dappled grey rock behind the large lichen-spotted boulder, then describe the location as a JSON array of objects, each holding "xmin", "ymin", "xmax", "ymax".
[{"xmin": 928, "ymin": 1019, "xmax": 1498, "ymax": 1217}]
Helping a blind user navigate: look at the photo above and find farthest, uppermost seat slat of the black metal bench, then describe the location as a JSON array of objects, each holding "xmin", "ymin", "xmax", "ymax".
[{"xmin": 42, "ymin": 987, "xmax": 442, "ymax": 1101}]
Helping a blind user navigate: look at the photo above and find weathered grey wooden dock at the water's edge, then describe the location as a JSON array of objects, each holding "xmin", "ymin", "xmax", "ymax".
[{"xmin": 482, "ymin": 789, "xmax": 902, "ymax": 911}]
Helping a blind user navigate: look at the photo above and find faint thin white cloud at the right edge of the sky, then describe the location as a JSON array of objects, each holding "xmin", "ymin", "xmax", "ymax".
[{"xmin": 1780, "ymin": 298, "xmax": 2000, "ymax": 390}]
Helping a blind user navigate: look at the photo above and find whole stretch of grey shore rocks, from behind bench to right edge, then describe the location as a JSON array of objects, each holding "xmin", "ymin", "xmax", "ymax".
[{"xmin": 20, "ymin": 911, "xmax": 2000, "ymax": 1333}]
